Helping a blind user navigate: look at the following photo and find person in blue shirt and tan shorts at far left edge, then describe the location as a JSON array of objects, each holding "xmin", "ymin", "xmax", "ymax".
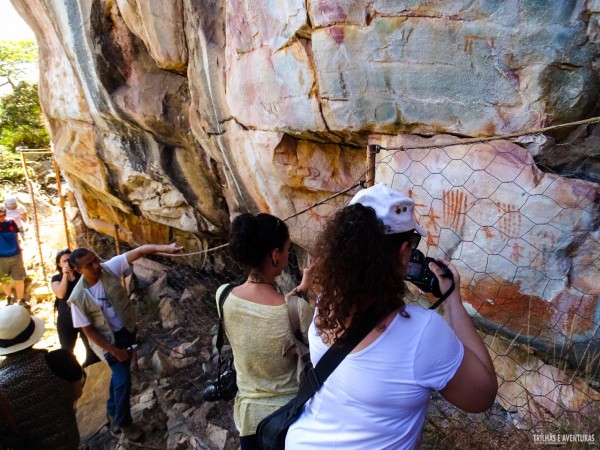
[{"xmin": 0, "ymin": 206, "xmax": 28, "ymax": 306}]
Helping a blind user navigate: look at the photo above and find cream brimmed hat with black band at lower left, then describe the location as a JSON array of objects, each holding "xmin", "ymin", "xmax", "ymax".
[{"xmin": 0, "ymin": 305, "xmax": 45, "ymax": 356}]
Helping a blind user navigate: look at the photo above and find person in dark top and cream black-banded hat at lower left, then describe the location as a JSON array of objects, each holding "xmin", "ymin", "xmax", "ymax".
[{"xmin": 0, "ymin": 305, "xmax": 85, "ymax": 450}]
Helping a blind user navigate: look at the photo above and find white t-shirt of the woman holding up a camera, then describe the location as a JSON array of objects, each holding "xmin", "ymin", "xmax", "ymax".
[{"xmin": 286, "ymin": 305, "xmax": 464, "ymax": 450}]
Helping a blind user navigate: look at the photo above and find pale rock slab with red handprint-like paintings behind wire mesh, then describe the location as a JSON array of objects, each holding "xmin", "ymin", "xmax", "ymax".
[{"xmin": 371, "ymin": 136, "xmax": 600, "ymax": 380}]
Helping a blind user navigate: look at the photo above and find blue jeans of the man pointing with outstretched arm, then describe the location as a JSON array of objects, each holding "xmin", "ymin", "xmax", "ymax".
[{"xmin": 104, "ymin": 328, "xmax": 135, "ymax": 427}]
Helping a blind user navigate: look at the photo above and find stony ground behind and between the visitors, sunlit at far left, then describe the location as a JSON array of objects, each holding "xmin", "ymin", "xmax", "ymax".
[{"xmin": 0, "ymin": 171, "xmax": 238, "ymax": 450}]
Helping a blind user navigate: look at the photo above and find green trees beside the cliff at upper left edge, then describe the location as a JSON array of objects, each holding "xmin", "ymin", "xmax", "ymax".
[{"xmin": 0, "ymin": 40, "xmax": 50, "ymax": 183}]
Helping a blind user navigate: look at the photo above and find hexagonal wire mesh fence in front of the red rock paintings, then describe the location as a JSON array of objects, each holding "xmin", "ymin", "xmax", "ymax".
[{"xmin": 81, "ymin": 116, "xmax": 600, "ymax": 449}]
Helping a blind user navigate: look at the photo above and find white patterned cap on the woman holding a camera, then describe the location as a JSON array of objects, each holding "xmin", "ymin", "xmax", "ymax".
[{"xmin": 348, "ymin": 183, "xmax": 427, "ymax": 236}]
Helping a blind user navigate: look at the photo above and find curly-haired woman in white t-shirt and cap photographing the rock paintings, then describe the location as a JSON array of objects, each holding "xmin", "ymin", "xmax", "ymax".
[{"xmin": 286, "ymin": 184, "xmax": 498, "ymax": 450}]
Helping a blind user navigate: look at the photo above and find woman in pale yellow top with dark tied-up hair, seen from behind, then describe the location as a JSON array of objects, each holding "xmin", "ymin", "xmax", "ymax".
[{"xmin": 216, "ymin": 213, "xmax": 313, "ymax": 450}]
